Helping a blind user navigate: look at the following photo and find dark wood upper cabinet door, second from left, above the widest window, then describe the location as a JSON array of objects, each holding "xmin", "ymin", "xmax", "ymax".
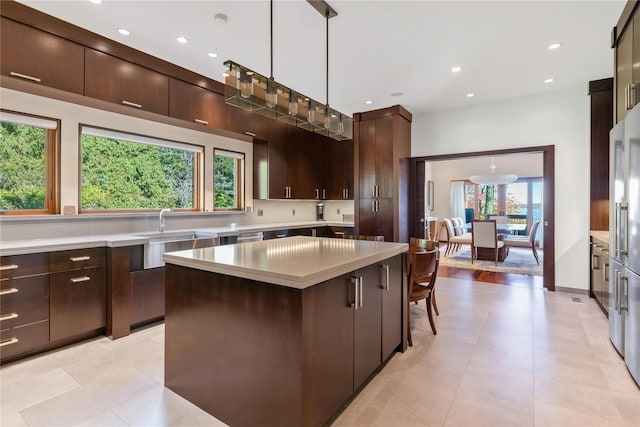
[{"xmin": 84, "ymin": 49, "xmax": 169, "ymax": 116}]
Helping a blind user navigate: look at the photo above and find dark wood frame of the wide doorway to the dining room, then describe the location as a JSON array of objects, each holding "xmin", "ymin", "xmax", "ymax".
[{"xmin": 409, "ymin": 145, "xmax": 555, "ymax": 291}]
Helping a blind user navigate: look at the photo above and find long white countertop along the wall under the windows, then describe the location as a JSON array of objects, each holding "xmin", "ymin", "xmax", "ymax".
[{"xmin": 0, "ymin": 221, "xmax": 353, "ymax": 256}]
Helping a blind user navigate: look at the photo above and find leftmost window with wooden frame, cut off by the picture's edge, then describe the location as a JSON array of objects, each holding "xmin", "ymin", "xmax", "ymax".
[{"xmin": 0, "ymin": 111, "xmax": 59, "ymax": 214}]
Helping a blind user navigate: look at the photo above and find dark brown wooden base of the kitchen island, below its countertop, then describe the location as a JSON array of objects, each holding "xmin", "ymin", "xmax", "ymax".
[{"xmin": 165, "ymin": 255, "xmax": 405, "ymax": 426}]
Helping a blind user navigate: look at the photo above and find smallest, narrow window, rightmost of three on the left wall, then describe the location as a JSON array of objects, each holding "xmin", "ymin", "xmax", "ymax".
[{"xmin": 214, "ymin": 150, "xmax": 244, "ymax": 210}]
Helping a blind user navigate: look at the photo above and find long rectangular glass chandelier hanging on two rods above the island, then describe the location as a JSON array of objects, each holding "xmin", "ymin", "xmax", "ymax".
[{"xmin": 224, "ymin": 0, "xmax": 353, "ymax": 141}]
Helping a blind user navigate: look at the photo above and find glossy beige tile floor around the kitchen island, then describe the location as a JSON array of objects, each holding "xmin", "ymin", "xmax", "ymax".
[{"xmin": 0, "ymin": 277, "xmax": 640, "ymax": 427}]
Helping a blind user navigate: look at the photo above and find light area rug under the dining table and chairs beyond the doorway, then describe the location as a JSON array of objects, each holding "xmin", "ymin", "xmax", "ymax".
[{"xmin": 440, "ymin": 246, "xmax": 544, "ymax": 276}]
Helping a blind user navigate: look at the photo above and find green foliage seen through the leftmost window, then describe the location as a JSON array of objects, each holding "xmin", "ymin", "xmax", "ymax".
[{"xmin": 0, "ymin": 122, "xmax": 46, "ymax": 210}]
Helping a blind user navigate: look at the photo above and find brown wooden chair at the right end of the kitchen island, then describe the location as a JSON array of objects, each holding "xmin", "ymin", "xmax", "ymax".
[{"xmin": 405, "ymin": 249, "xmax": 440, "ymax": 346}]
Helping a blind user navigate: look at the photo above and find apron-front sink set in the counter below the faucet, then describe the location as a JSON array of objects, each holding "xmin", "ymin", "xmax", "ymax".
[{"xmin": 137, "ymin": 232, "xmax": 218, "ymax": 269}]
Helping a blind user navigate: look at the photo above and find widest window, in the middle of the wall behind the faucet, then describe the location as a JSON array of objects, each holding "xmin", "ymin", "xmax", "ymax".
[{"xmin": 80, "ymin": 126, "xmax": 203, "ymax": 212}]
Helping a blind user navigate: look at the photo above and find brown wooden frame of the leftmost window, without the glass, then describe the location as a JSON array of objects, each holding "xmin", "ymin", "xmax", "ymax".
[{"xmin": 0, "ymin": 109, "xmax": 62, "ymax": 215}]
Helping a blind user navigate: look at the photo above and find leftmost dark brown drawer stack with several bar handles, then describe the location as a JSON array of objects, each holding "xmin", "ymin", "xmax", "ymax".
[{"xmin": 0, "ymin": 253, "xmax": 49, "ymax": 360}]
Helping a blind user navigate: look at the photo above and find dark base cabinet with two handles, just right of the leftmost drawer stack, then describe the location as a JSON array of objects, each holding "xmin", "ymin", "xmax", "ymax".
[{"xmin": 49, "ymin": 248, "xmax": 107, "ymax": 342}]
